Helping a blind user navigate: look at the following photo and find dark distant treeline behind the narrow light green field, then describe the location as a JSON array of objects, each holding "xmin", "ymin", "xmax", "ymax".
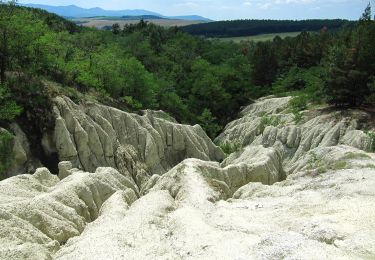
[{"xmin": 182, "ymin": 19, "xmax": 353, "ymax": 37}]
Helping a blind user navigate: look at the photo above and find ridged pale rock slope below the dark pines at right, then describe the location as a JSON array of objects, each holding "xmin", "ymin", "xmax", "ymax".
[{"xmin": 216, "ymin": 97, "xmax": 372, "ymax": 174}]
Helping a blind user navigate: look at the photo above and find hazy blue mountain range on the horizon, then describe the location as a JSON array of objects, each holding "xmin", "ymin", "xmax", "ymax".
[{"xmin": 22, "ymin": 4, "xmax": 211, "ymax": 21}]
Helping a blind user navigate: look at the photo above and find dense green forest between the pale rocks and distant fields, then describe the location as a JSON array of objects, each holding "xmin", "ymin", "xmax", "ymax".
[{"xmin": 0, "ymin": 3, "xmax": 375, "ymax": 137}]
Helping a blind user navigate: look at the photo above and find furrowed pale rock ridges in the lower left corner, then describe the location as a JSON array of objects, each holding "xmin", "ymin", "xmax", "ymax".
[{"xmin": 0, "ymin": 168, "xmax": 139, "ymax": 259}]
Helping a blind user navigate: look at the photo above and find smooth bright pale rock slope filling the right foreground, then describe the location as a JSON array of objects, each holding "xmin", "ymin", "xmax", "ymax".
[{"xmin": 55, "ymin": 147, "xmax": 375, "ymax": 259}]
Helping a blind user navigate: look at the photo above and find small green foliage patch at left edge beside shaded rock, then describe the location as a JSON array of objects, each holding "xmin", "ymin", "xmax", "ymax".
[{"xmin": 0, "ymin": 131, "xmax": 14, "ymax": 181}]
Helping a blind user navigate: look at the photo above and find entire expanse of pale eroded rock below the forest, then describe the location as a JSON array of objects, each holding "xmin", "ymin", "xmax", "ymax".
[{"xmin": 0, "ymin": 97, "xmax": 375, "ymax": 259}]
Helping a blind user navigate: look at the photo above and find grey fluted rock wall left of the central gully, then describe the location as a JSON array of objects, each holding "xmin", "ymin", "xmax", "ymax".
[{"xmin": 54, "ymin": 97, "xmax": 224, "ymax": 187}]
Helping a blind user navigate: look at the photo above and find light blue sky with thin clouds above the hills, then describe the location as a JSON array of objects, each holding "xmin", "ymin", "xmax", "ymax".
[{"xmin": 19, "ymin": 0, "xmax": 375, "ymax": 20}]
